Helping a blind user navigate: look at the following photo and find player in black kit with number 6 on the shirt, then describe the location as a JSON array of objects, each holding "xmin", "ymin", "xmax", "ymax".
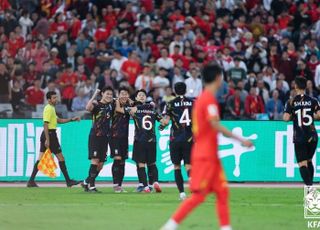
[{"xmin": 131, "ymin": 89, "xmax": 164, "ymax": 193}]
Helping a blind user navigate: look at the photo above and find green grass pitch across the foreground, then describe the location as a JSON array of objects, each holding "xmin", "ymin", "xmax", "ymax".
[{"xmin": 0, "ymin": 188, "xmax": 307, "ymax": 230}]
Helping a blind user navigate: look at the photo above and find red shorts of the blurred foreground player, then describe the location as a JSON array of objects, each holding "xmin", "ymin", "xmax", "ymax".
[{"xmin": 190, "ymin": 160, "xmax": 227, "ymax": 194}]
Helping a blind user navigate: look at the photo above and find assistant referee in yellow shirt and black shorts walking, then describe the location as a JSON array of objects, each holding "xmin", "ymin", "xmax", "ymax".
[{"xmin": 27, "ymin": 91, "xmax": 80, "ymax": 187}]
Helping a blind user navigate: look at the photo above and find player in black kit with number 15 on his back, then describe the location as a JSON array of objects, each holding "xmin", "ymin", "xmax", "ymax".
[{"xmin": 283, "ymin": 77, "xmax": 320, "ymax": 186}]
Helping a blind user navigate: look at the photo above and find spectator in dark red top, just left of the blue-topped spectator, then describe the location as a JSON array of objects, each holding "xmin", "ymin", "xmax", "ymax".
[{"xmin": 245, "ymin": 86, "xmax": 265, "ymax": 119}]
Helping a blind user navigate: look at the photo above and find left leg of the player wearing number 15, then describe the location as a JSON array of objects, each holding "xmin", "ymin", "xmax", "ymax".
[{"xmin": 294, "ymin": 143, "xmax": 312, "ymax": 186}]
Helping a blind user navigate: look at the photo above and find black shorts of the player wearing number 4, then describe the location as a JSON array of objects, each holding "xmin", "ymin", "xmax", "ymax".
[{"xmin": 170, "ymin": 142, "xmax": 192, "ymax": 165}]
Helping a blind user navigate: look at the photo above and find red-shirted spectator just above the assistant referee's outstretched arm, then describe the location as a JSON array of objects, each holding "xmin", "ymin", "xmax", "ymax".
[{"xmin": 59, "ymin": 64, "xmax": 78, "ymax": 111}]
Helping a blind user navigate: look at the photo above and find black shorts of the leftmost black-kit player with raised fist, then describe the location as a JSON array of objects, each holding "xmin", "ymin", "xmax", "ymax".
[{"xmin": 88, "ymin": 135, "xmax": 109, "ymax": 162}]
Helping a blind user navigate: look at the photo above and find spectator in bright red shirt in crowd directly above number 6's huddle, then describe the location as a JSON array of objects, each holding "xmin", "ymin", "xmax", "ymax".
[{"xmin": 121, "ymin": 51, "xmax": 141, "ymax": 86}]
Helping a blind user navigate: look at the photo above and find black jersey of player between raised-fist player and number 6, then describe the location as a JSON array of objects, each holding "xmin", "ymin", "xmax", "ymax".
[{"xmin": 112, "ymin": 104, "xmax": 130, "ymax": 138}]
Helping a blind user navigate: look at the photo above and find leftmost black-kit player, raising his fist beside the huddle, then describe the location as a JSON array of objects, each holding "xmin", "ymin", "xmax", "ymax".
[{"xmin": 82, "ymin": 86, "xmax": 120, "ymax": 192}]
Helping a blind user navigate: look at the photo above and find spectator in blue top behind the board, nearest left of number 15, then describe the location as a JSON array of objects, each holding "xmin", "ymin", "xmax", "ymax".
[{"xmin": 266, "ymin": 90, "xmax": 283, "ymax": 120}]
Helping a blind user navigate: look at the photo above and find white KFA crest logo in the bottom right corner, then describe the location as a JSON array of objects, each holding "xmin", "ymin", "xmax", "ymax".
[{"xmin": 304, "ymin": 186, "xmax": 320, "ymax": 228}]
